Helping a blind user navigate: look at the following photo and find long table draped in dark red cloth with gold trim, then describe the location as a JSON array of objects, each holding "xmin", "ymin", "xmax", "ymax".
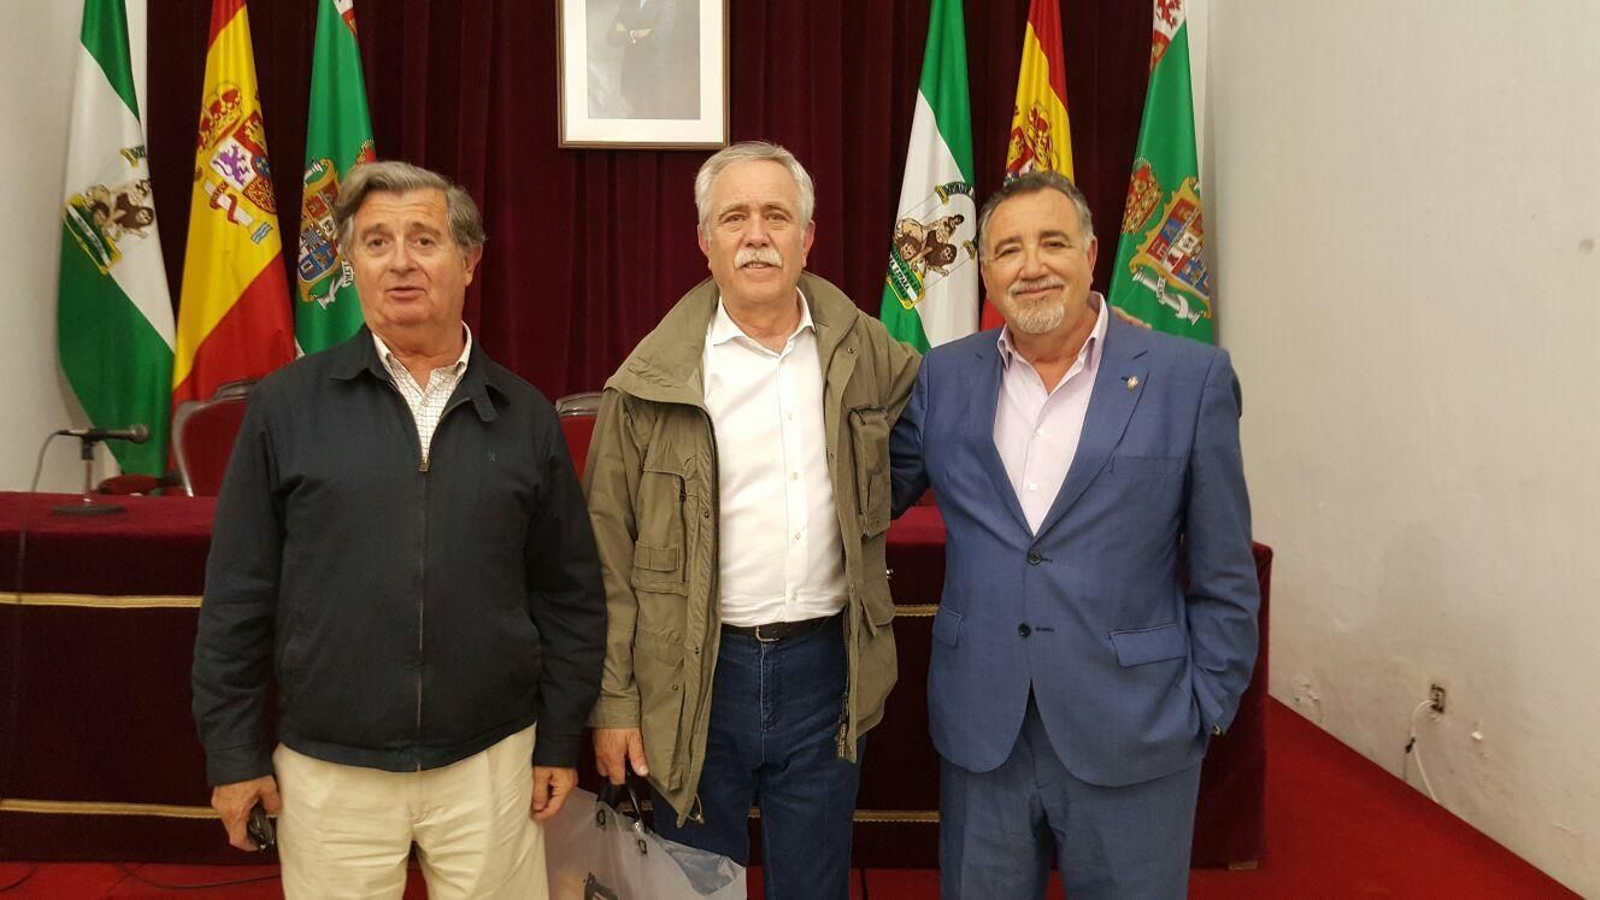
[{"xmin": 0, "ymin": 493, "xmax": 1272, "ymax": 868}]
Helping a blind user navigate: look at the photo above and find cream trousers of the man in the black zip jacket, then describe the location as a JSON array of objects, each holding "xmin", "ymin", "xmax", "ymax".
[{"xmin": 272, "ymin": 725, "xmax": 549, "ymax": 900}]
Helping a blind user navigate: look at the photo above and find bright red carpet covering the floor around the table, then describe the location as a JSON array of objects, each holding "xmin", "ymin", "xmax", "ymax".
[{"xmin": 0, "ymin": 701, "xmax": 1578, "ymax": 900}]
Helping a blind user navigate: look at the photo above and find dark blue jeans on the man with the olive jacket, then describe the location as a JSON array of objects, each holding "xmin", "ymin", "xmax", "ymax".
[{"xmin": 653, "ymin": 617, "xmax": 862, "ymax": 900}]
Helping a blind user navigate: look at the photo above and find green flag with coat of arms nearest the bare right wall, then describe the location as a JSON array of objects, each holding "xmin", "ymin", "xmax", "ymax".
[{"xmin": 1110, "ymin": 0, "xmax": 1211, "ymax": 343}]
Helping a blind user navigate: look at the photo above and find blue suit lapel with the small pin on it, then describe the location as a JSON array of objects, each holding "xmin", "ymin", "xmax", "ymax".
[{"xmin": 1038, "ymin": 315, "xmax": 1149, "ymax": 535}]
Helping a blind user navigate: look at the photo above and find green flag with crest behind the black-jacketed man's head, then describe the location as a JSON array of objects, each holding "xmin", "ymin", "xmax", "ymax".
[{"xmin": 294, "ymin": 0, "xmax": 374, "ymax": 354}]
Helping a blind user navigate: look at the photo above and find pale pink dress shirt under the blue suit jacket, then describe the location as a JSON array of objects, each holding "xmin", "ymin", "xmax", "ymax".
[{"xmin": 995, "ymin": 293, "xmax": 1107, "ymax": 533}]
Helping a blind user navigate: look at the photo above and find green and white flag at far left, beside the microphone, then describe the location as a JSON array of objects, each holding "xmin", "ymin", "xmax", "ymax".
[{"xmin": 56, "ymin": 0, "xmax": 173, "ymax": 476}]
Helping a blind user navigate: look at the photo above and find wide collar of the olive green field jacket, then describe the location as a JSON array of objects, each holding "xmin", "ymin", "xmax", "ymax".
[{"xmin": 608, "ymin": 272, "xmax": 858, "ymax": 407}]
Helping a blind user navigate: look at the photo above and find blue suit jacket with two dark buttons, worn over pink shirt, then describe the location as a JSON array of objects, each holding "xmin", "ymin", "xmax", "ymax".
[{"xmin": 891, "ymin": 317, "xmax": 1261, "ymax": 786}]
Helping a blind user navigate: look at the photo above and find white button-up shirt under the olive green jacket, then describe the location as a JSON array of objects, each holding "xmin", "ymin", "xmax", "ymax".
[{"xmin": 702, "ymin": 296, "xmax": 846, "ymax": 626}]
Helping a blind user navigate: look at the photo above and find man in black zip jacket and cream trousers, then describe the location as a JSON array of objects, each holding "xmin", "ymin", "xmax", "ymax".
[{"xmin": 194, "ymin": 162, "xmax": 605, "ymax": 898}]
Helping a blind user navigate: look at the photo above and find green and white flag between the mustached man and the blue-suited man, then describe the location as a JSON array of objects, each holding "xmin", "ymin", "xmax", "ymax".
[{"xmin": 878, "ymin": 0, "xmax": 978, "ymax": 352}]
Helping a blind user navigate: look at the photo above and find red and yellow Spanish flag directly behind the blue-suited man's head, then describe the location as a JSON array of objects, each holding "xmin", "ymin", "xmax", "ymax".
[{"xmin": 982, "ymin": 0, "xmax": 1072, "ymax": 328}]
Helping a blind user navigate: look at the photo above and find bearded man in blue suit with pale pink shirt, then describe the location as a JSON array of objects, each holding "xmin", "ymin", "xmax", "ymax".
[{"xmin": 891, "ymin": 171, "xmax": 1261, "ymax": 900}]
